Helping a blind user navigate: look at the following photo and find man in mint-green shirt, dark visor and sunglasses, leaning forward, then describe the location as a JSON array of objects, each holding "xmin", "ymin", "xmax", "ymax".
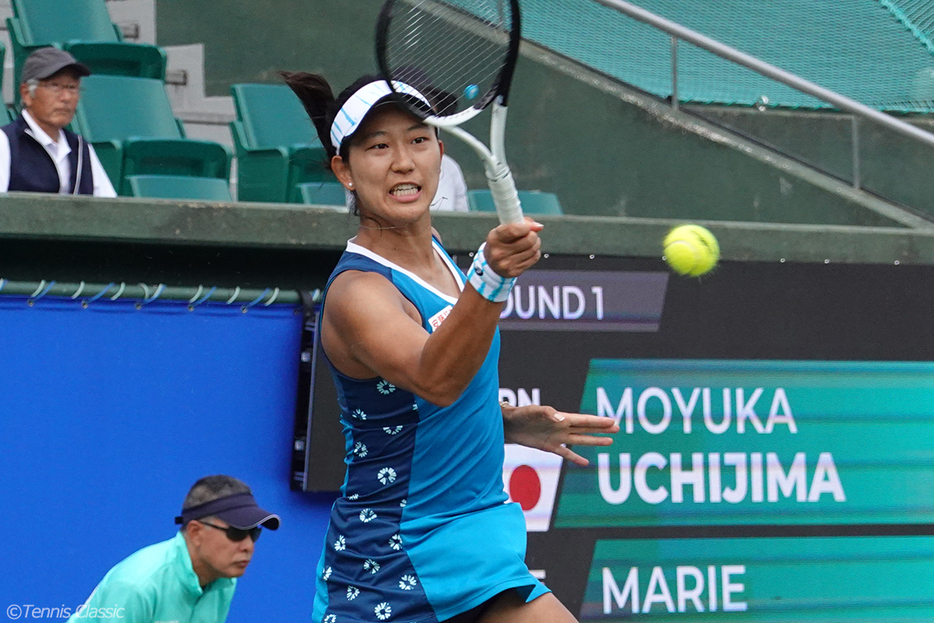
[{"xmin": 68, "ymin": 476, "xmax": 279, "ymax": 623}]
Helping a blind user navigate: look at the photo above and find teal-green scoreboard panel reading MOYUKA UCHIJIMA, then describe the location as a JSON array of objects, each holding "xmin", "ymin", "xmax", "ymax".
[{"xmin": 555, "ymin": 359, "xmax": 934, "ymax": 528}]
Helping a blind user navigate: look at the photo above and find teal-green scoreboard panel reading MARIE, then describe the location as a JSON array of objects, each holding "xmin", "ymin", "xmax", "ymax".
[{"xmin": 580, "ymin": 537, "xmax": 934, "ymax": 623}]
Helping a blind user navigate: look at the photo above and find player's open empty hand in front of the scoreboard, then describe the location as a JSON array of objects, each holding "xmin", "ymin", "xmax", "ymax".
[{"xmin": 503, "ymin": 405, "xmax": 619, "ymax": 466}]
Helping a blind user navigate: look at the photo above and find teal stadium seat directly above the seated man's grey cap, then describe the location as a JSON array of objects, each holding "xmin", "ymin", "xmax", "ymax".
[{"xmin": 6, "ymin": 0, "xmax": 166, "ymax": 102}]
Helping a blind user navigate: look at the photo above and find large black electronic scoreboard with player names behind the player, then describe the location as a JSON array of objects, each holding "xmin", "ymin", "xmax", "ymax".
[{"xmin": 296, "ymin": 256, "xmax": 934, "ymax": 622}]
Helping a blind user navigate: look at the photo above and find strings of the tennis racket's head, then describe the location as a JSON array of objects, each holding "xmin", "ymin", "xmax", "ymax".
[{"xmin": 385, "ymin": 0, "xmax": 512, "ymax": 113}]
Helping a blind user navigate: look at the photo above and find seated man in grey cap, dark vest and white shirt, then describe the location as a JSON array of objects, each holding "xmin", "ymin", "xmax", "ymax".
[{"xmin": 0, "ymin": 47, "xmax": 117, "ymax": 197}]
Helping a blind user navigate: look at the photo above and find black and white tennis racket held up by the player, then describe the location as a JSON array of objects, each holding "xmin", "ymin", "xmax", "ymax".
[{"xmin": 376, "ymin": 0, "xmax": 522, "ymax": 223}]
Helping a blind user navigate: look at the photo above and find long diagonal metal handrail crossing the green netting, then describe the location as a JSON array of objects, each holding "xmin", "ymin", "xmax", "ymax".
[{"xmin": 595, "ymin": 0, "xmax": 934, "ymax": 147}]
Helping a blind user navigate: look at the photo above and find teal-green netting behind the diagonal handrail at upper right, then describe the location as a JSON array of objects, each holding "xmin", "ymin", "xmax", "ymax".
[{"xmin": 522, "ymin": 0, "xmax": 934, "ymax": 113}]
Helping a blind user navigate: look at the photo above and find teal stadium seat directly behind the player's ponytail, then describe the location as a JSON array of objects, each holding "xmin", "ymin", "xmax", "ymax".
[{"xmin": 230, "ymin": 84, "xmax": 333, "ymax": 203}]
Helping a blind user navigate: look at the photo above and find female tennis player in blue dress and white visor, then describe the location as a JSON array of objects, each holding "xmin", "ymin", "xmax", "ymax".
[{"xmin": 283, "ymin": 73, "xmax": 618, "ymax": 623}]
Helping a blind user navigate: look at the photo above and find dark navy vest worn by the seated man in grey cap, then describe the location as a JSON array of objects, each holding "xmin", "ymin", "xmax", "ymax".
[{"xmin": 2, "ymin": 115, "xmax": 94, "ymax": 195}]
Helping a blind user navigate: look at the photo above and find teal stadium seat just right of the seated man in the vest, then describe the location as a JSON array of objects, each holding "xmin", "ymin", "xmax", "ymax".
[{"xmin": 72, "ymin": 75, "xmax": 230, "ymax": 195}]
